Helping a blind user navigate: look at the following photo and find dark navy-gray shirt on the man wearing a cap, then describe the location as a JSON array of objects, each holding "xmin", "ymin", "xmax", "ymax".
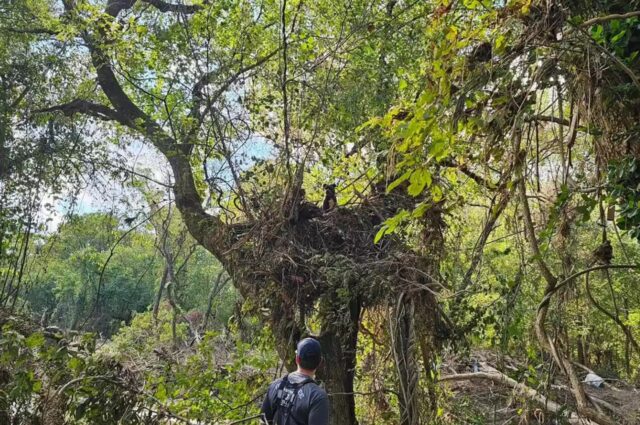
[{"xmin": 261, "ymin": 372, "xmax": 329, "ymax": 425}]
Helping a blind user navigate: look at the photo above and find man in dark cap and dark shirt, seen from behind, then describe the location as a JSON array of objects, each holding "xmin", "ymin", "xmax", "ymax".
[{"xmin": 261, "ymin": 338, "xmax": 329, "ymax": 425}]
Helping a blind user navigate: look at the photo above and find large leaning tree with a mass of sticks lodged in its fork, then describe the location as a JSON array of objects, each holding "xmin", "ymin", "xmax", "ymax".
[{"xmin": 19, "ymin": 0, "xmax": 437, "ymax": 424}]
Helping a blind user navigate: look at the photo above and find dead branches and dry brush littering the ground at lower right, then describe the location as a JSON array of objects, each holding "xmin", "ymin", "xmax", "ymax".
[{"xmin": 439, "ymin": 350, "xmax": 640, "ymax": 425}]
